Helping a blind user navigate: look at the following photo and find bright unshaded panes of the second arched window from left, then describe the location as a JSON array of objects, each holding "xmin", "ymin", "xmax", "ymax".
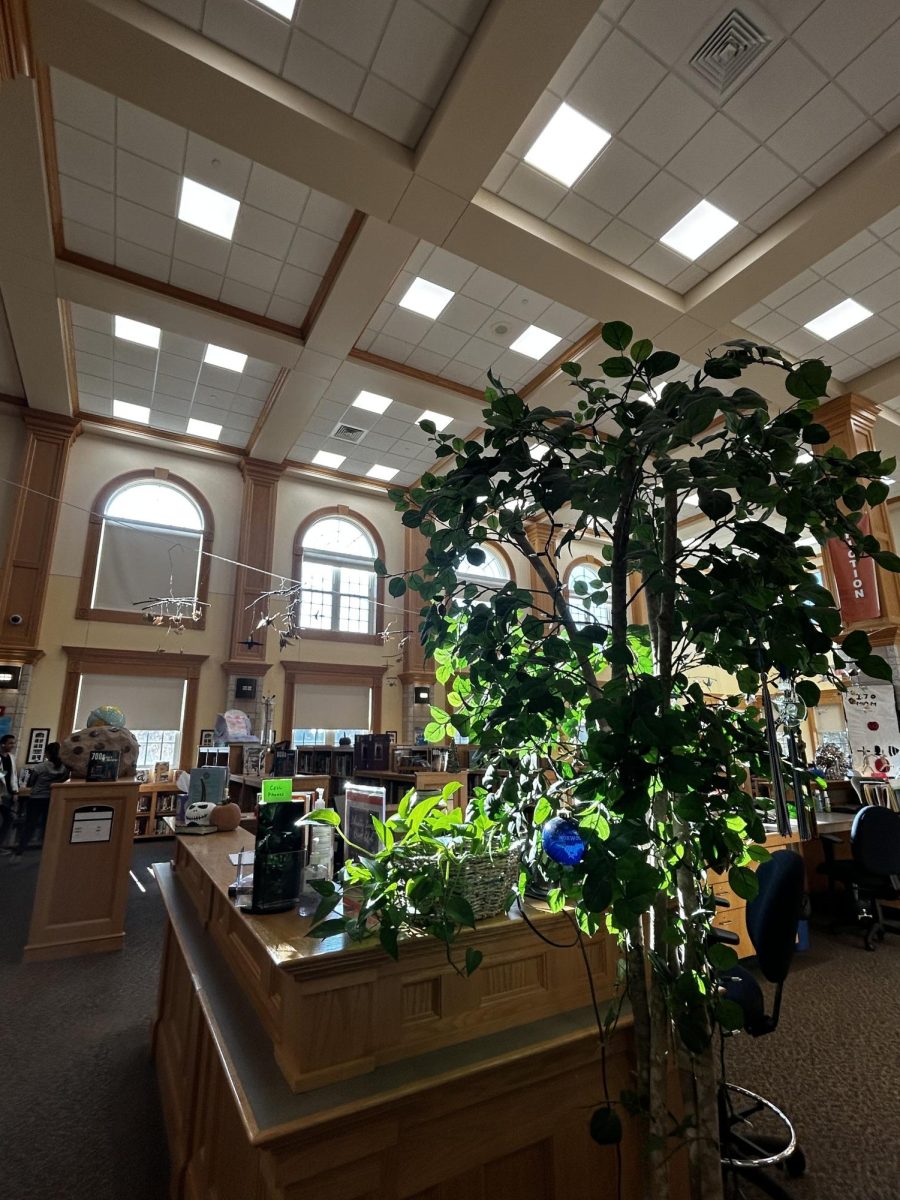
[{"xmin": 298, "ymin": 514, "xmax": 380, "ymax": 635}]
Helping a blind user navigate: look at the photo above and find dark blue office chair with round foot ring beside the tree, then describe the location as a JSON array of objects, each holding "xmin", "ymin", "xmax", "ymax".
[{"xmin": 719, "ymin": 850, "xmax": 806, "ymax": 1200}]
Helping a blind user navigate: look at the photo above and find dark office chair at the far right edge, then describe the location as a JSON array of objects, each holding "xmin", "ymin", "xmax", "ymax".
[{"xmin": 816, "ymin": 804, "xmax": 900, "ymax": 950}]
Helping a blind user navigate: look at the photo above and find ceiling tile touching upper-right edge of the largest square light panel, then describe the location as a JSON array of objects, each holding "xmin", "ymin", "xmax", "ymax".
[{"xmin": 566, "ymin": 29, "xmax": 666, "ymax": 133}]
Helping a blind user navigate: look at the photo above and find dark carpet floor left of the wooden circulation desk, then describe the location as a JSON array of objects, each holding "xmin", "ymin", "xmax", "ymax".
[{"xmin": 0, "ymin": 842, "xmax": 170, "ymax": 1200}]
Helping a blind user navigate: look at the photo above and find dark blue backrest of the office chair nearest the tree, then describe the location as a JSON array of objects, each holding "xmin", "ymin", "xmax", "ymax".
[{"xmin": 746, "ymin": 850, "xmax": 805, "ymax": 983}]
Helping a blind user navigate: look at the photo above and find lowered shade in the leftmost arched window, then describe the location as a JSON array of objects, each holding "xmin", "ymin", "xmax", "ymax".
[{"xmin": 94, "ymin": 521, "xmax": 200, "ymax": 612}]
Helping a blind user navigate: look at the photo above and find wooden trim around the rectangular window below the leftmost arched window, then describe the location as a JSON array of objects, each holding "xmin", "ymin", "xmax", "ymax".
[{"xmin": 56, "ymin": 646, "xmax": 209, "ymax": 768}]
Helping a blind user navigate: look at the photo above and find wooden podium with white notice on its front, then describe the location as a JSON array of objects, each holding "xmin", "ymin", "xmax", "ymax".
[{"xmin": 25, "ymin": 780, "xmax": 139, "ymax": 962}]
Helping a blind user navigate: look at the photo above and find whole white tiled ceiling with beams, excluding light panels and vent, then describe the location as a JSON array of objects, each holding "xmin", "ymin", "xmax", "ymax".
[{"xmin": 0, "ymin": 0, "xmax": 900, "ymax": 482}]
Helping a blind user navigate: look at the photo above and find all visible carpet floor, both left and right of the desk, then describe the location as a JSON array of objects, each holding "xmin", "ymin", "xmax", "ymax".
[{"xmin": 0, "ymin": 842, "xmax": 900, "ymax": 1200}]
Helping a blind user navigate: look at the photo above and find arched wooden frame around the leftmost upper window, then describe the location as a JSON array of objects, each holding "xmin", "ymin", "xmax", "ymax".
[{"xmin": 76, "ymin": 468, "xmax": 215, "ymax": 630}]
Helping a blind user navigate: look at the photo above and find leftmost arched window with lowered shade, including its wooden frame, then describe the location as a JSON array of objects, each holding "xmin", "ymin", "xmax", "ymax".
[{"xmin": 77, "ymin": 470, "xmax": 212, "ymax": 629}]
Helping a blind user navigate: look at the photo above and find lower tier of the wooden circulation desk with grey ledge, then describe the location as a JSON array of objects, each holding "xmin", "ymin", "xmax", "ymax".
[{"xmin": 154, "ymin": 864, "xmax": 688, "ymax": 1200}]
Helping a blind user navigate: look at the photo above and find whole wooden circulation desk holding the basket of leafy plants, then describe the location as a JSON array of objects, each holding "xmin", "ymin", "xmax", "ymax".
[{"xmin": 154, "ymin": 830, "xmax": 686, "ymax": 1200}]
